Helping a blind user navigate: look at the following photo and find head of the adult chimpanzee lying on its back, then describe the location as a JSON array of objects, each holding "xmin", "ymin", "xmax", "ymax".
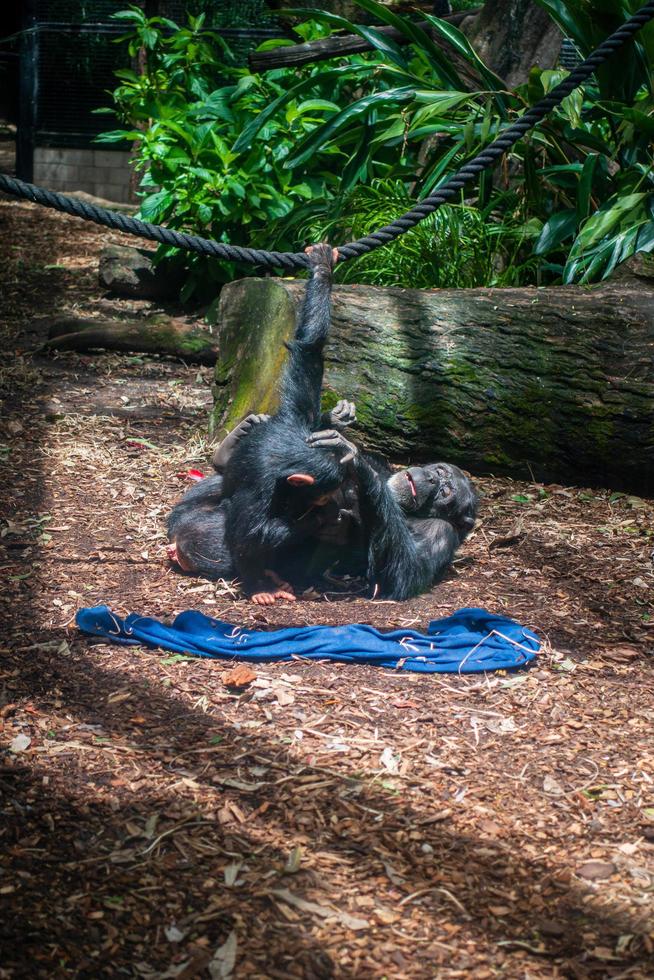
[{"xmin": 388, "ymin": 463, "xmax": 477, "ymax": 530}]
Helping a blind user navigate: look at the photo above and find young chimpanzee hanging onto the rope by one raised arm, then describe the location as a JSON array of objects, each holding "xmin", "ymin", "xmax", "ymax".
[{"xmin": 223, "ymin": 245, "xmax": 354, "ymax": 592}]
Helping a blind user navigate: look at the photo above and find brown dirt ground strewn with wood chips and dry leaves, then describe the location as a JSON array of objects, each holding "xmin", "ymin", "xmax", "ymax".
[{"xmin": 0, "ymin": 191, "xmax": 654, "ymax": 980}]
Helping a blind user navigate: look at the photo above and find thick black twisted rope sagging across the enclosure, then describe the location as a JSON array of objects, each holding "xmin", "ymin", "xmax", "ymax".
[{"xmin": 0, "ymin": 0, "xmax": 654, "ymax": 271}]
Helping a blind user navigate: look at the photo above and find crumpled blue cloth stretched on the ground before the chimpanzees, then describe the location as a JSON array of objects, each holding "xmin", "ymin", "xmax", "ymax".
[{"xmin": 75, "ymin": 606, "xmax": 540, "ymax": 674}]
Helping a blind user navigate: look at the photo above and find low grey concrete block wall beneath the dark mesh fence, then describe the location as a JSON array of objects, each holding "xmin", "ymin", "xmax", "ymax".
[{"xmin": 33, "ymin": 146, "xmax": 132, "ymax": 204}]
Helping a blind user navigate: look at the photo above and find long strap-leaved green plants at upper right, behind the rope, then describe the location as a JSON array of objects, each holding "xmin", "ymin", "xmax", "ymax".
[{"xmin": 249, "ymin": 0, "xmax": 654, "ymax": 282}]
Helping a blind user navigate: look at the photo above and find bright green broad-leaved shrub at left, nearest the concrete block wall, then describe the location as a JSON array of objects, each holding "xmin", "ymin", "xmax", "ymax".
[{"xmin": 99, "ymin": 8, "xmax": 346, "ymax": 298}]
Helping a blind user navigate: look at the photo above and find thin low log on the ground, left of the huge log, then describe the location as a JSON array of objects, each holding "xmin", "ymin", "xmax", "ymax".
[{"xmin": 43, "ymin": 313, "xmax": 218, "ymax": 365}]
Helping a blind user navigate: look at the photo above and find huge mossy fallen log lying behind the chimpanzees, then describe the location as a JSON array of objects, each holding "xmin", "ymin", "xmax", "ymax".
[{"xmin": 211, "ymin": 277, "xmax": 654, "ymax": 493}]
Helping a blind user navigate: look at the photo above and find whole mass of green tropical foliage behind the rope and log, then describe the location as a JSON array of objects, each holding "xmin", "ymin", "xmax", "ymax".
[{"xmin": 104, "ymin": 0, "xmax": 654, "ymax": 291}]
